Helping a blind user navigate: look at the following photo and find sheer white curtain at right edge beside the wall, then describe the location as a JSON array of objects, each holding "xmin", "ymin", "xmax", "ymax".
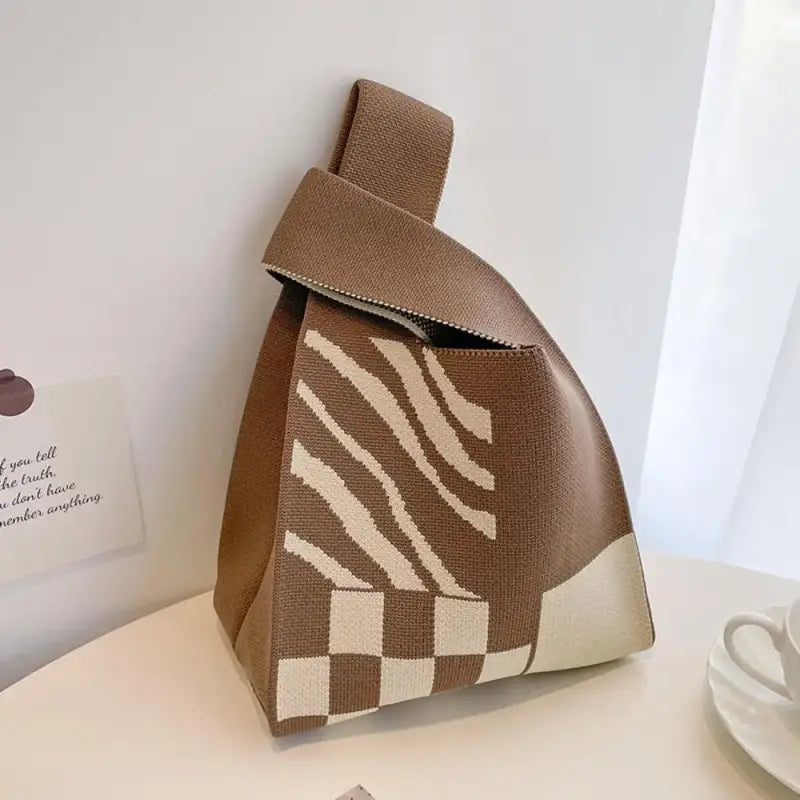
[{"xmin": 637, "ymin": 0, "xmax": 800, "ymax": 578}]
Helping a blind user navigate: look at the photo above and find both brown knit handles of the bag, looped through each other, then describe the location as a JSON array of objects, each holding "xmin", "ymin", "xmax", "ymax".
[{"xmin": 264, "ymin": 81, "xmax": 552, "ymax": 348}]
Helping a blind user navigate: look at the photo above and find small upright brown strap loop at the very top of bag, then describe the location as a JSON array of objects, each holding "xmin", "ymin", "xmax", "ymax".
[{"xmin": 328, "ymin": 80, "xmax": 453, "ymax": 223}]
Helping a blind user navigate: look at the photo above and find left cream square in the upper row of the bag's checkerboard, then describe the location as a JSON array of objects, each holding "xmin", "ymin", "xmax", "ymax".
[{"xmin": 328, "ymin": 590, "xmax": 383, "ymax": 656}]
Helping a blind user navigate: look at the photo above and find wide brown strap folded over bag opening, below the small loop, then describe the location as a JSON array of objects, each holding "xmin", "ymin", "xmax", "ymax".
[{"xmin": 264, "ymin": 169, "xmax": 549, "ymax": 347}]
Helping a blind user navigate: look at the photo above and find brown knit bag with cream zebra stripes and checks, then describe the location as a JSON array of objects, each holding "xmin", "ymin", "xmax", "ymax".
[{"xmin": 214, "ymin": 81, "xmax": 653, "ymax": 736}]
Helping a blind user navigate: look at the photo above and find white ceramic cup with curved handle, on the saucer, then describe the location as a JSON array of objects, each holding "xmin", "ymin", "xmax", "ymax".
[{"xmin": 723, "ymin": 600, "xmax": 800, "ymax": 705}]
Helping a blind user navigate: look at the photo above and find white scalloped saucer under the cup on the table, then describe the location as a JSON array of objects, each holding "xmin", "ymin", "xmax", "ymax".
[{"xmin": 706, "ymin": 607, "xmax": 800, "ymax": 793}]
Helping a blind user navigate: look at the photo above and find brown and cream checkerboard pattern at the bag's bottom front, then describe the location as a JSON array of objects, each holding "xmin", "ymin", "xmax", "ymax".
[{"xmin": 276, "ymin": 589, "xmax": 531, "ymax": 724}]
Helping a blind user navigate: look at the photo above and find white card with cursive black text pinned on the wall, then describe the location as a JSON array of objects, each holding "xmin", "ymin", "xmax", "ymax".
[{"xmin": 0, "ymin": 378, "xmax": 144, "ymax": 582}]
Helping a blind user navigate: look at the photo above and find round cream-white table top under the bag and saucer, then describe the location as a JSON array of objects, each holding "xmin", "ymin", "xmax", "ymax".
[{"xmin": 0, "ymin": 556, "xmax": 800, "ymax": 800}]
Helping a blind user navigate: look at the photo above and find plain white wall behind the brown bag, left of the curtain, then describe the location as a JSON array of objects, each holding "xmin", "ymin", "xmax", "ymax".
[{"xmin": 0, "ymin": 0, "xmax": 712, "ymax": 685}]
